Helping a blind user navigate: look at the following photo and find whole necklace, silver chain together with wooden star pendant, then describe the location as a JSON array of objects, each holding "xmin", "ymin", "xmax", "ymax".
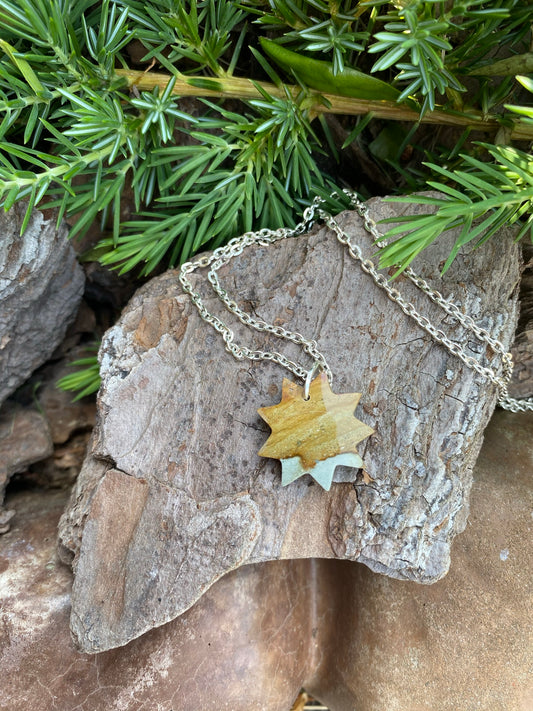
[{"xmin": 179, "ymin": 190, "xmax": 533, "ymax": 491}]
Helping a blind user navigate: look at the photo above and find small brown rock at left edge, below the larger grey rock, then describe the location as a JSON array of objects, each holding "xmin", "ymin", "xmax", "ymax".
[{"xmin": 0, "ymin": 402, "xmax": 53, "ymax": 525}]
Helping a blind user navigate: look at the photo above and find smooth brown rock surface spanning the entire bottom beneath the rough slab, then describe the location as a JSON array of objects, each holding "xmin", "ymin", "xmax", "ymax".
[{"xmin": 0, "ymin": 411, "xmax": 533, "ymax": 711}]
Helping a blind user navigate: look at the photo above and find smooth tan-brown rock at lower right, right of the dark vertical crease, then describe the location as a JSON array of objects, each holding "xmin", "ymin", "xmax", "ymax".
[{"xmin": 305, "ymin": 411, "xmax": 533, "ymax": 711}]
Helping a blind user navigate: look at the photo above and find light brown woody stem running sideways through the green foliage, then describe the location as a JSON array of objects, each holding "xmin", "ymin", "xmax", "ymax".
[{"xmin": 115, "ymin": 69, "xmax": 533, "ymax": 140}]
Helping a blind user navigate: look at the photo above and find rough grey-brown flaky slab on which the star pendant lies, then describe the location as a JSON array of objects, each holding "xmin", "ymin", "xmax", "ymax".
[{"xmin": 61, "ymin": 200, "xmax": 520, "ymax": 652}]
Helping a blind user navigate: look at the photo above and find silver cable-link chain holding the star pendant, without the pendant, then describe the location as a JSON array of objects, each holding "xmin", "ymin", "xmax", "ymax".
[{"xmin": 179, "ymin": 190, "xmax": 533, "ymax": 412}]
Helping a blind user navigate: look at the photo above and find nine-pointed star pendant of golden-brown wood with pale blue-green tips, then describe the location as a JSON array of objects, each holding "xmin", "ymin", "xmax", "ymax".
[{"xmin": 258, "ymin": 373, "xmax": 374, "ymax": 491}]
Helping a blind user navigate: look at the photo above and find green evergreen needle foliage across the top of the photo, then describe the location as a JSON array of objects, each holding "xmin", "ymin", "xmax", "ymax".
[{"xmin": 0, "ymin": 0, "xmax": 533, "ymax": 274}]
